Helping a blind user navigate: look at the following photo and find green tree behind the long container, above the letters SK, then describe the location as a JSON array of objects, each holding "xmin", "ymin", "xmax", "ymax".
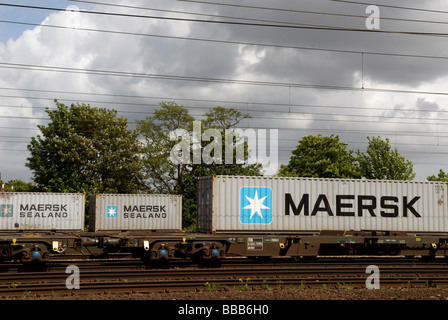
[{"xmin": 357, "ymin": 137, "xmax": 415, "ymax": 180}]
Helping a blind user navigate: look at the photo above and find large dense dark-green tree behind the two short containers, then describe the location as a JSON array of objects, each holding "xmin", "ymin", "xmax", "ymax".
[{"xmin": 26, "ymin": 100, "xmax": 144, "ymax": 193}]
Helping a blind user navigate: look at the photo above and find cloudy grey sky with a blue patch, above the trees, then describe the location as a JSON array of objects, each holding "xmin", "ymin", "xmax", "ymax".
[{"xmin": 0, "ymin": 0, "xmax": 448, "ymax": 181}]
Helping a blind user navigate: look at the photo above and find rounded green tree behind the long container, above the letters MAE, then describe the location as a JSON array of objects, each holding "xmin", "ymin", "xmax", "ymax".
[{"xmin": 279, "ymin": 134, "xmax": 360, "ymax": 179}]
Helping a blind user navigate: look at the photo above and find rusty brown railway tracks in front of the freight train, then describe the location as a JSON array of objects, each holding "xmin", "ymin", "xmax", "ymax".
[{"xmin": 0, "ymin": 258, "xmax": 448, "ymax": 297}]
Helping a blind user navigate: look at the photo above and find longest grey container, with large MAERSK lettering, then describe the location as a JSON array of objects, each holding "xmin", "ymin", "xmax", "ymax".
[{"xmin": 198, "ymin": 176, "xmax": 448, "ymax": 233}]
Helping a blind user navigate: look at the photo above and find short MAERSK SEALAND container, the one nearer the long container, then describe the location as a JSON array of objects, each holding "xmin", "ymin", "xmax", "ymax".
[{"xmin": 89, "ymin": 194, "xmax": 182, "ymax": 231}]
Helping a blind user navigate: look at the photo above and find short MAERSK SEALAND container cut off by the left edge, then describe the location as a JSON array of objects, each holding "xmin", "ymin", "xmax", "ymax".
[{"xmin": 0, "ymin": 192, "xmax": 85, "ymax": 231}]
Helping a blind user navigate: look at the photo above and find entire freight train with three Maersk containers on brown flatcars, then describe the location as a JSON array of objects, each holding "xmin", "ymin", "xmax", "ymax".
[{"xmin": 0, "ymin": 176, "xmax": 448, "ymax": 263}]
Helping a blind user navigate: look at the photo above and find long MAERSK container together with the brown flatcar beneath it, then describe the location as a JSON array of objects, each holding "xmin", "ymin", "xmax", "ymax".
[{"xmin": 198, "ymin": 176, "xmax": 448, "ymax": 257}]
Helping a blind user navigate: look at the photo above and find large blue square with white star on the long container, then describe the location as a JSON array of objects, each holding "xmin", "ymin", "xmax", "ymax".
[{"xmin": 240, "ymin": 187, "xmax": 272, "ymax": 224}]
